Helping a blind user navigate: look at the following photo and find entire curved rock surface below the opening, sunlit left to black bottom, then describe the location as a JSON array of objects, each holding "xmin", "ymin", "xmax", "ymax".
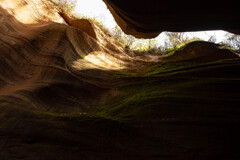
[{"xmin": 0, "ymin": 0, "xmax": 240, "ymax": 160}]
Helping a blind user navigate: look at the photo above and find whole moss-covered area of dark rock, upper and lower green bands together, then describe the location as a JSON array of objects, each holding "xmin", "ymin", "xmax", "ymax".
[{"xmin": 42, "ymin": 59, "xmax": 240, "ymax": 123}]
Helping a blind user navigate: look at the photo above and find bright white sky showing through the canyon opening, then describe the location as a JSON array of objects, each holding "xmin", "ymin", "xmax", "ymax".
[{"xmin": 75, "ymin": 0, "xmax": 226, "ymax": 43}]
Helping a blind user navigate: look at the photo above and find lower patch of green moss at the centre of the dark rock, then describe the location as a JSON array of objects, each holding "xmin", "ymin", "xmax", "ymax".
[{"xmin": 94, "ymin": 80, "xmax": 201, "ymax": 122}]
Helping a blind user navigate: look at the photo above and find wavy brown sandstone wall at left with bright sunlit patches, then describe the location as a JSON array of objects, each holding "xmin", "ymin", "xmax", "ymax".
[{"xmin": 0, "ymin": 1, "xmax": 137, "ymax": 112}]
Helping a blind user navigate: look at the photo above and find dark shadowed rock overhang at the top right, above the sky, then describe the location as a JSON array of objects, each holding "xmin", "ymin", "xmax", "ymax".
[{"xmin": 104, "ymin": 0, "xmax": 240, "ymax": 38}]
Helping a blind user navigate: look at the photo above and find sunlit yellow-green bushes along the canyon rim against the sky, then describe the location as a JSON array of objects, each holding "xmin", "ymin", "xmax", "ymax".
[{"xmin": 51, "ymin": 0, "xmax": 240, "ymax": 54}]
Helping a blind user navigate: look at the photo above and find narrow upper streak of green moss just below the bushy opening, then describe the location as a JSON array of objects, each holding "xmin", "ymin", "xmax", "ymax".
[{"xmin": 113, "ymin": 59, "xmax": 240, "ymax": 78}]
